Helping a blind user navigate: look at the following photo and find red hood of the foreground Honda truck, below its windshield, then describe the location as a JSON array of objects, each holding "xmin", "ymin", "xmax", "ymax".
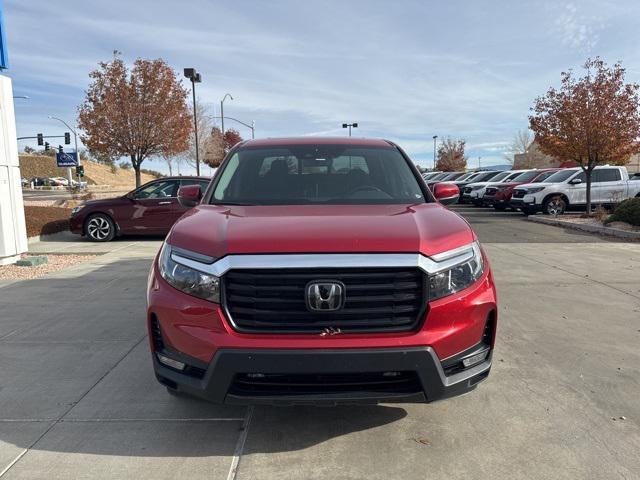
[{"xmin": 167, "ymin": 203, "xmax": 475, "ymax": 258}]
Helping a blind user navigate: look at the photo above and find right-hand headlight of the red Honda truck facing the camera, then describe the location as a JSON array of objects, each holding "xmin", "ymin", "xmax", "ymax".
[{"xmin": 429, "ymin": 242, "xmax": 484, "ymax": 300}]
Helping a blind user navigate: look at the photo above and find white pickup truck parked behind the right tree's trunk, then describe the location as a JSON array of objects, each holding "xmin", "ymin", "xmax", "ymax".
[{"xmin": 509, "ymin": 165, "xmax": 640, "ymax": 215}]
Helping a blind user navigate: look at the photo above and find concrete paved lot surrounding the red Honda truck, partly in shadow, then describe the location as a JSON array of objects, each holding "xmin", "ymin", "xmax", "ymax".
[{"xmin": 0, "ymin": 206, "xmax": 640, "ymax": 480}]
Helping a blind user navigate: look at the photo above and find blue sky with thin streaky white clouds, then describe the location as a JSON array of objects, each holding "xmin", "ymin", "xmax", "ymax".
[{"xmin": 4, "ymin": 0, "xmax": 640, "ymax": 173}]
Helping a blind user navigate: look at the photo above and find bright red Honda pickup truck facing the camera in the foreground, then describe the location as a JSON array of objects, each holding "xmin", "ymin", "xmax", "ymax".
[{"xmin": 147, "ymin": 137, "xmax": 498, "ymax": 404}]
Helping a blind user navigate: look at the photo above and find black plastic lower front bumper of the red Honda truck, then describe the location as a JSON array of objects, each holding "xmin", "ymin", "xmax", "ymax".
[{"xmin": 153, "ymin": 347, "xmax": 492, "ymax": 405}]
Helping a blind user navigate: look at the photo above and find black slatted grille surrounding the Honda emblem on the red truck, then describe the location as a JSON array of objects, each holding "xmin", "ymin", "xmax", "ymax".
[{"xmin": 223, "ymin": 268, "xmax": 427, "ymax": 333}]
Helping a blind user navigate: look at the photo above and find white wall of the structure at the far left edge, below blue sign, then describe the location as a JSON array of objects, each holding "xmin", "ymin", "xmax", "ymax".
[{"xmin": 0, "ymin": 75, "xmax": 27, "ymax": 265}]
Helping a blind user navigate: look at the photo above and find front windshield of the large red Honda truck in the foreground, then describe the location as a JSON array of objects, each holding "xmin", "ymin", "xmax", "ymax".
[{"xmin": 210, "ymin": 145, "xmax": 425, "ymax": 205}]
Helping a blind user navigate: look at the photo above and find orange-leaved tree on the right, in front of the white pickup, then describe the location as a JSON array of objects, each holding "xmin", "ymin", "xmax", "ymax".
[{"xmin": 529, "ymin": 57, "xmax": 640, "ymax": 214}]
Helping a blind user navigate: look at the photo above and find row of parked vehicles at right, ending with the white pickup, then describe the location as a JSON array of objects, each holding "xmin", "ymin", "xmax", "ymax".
[{"xmin": 423, "ymin": 165, "xmax": 640, "ymax": 215}]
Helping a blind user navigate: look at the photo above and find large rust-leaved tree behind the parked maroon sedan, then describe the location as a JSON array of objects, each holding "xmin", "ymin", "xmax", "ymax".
[{"xmin": 78, "ymin": 52, "xmax": 192, "ymax": 186}]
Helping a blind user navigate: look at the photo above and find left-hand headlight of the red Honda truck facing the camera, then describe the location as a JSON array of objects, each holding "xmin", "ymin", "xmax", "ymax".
[{"xmin": 158, "ymin": 243, "xmax": 220, "ymax": 303}]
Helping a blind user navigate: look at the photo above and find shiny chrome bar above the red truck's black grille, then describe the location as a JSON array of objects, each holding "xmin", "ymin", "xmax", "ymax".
[{"xmin": 171, "ymin": 242, "xmax": 480, "ymax": 277}]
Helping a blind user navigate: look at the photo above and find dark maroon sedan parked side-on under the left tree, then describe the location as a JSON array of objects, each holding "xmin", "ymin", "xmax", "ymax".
[{"xmin": 70, "ymin": 177, "xmax": 210, "ymax": 242}]
